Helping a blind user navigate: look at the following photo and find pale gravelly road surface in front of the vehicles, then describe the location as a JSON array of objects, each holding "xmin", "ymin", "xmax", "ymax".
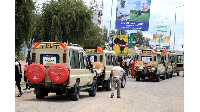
[{"xmin": 15, "ymin": 72, "xmax": 184, "ymax": 112}]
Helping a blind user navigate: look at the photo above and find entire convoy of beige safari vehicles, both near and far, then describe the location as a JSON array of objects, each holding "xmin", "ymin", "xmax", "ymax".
[{"xmin": 23, "ymin": 42, "xmax": 183, "ymax": 101}]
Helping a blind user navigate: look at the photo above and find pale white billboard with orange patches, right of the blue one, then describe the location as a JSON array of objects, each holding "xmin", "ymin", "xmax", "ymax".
[{"xmin": 152, "ymin": 25, "xmax": 170, "ymax": 46}]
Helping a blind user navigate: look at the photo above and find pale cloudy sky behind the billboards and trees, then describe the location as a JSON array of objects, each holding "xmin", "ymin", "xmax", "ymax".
[{"xmin": 36, "ymin": 0, "xmax": 184, "ymax": 50}]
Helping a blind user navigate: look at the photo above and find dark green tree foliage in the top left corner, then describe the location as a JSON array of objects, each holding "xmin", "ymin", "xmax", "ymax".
[{"xmin": 15, "ymin": 0, "xmax": 35, "ymax": 55}]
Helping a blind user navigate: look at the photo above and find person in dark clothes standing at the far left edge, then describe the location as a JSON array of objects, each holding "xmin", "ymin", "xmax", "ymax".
[{"xmin": 15, "ymin": 58, "xmax": 22, "ymax": 97}]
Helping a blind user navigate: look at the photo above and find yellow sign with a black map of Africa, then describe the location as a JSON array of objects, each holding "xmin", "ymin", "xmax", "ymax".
[{"xmin": 113, "ymin": 35, "xmax": 128, "ymax": 54}]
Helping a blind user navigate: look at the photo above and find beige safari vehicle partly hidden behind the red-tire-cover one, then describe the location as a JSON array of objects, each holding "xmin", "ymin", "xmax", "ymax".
[{"xmin": 84, "ymin": 47, "xmax": 126, "ymax": 91}]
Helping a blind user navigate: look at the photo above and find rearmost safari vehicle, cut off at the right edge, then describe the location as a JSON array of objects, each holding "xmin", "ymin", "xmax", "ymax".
[{"xmin": 170, "ymin": 51, "xmax": 184, "ymax": 76}]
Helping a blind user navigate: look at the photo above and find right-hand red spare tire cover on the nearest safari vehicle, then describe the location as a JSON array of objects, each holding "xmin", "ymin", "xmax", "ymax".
[{"xmin": 48, "ymin": 63, "xmax": 69, "ymax": 84}]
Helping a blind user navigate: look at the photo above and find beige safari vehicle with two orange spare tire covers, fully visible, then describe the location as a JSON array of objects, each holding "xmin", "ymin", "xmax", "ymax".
[{"xmin": 134, "ymin": 49, "xmax": 166, "ymax": 82}]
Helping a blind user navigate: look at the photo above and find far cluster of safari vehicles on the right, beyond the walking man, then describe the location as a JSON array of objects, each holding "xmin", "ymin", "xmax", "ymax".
[{"xmin": 134, "ymin": 49, "xmax": 183, "ymax": 82}]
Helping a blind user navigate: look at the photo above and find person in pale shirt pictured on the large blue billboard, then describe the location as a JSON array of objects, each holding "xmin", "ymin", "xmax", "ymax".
[{"xmin": 116, "ymin": 0, "xmax": 130, "ymax": 21}]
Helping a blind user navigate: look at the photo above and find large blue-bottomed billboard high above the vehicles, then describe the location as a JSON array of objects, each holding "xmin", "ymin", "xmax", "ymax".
[{"xmin": 115, "ymin": 0, "xmax": 151, "ymax": 31}]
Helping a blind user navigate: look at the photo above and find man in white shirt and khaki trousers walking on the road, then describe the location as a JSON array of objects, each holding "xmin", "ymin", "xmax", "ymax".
[{"xmin": 111, "ymin": 62, "xmax": 124, "ymax": 98}]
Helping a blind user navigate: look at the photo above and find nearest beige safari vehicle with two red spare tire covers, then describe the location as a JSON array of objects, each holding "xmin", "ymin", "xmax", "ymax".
[{"xmin": 26, "ymin": 42, "xmax": 97, "ymax": 101}]
